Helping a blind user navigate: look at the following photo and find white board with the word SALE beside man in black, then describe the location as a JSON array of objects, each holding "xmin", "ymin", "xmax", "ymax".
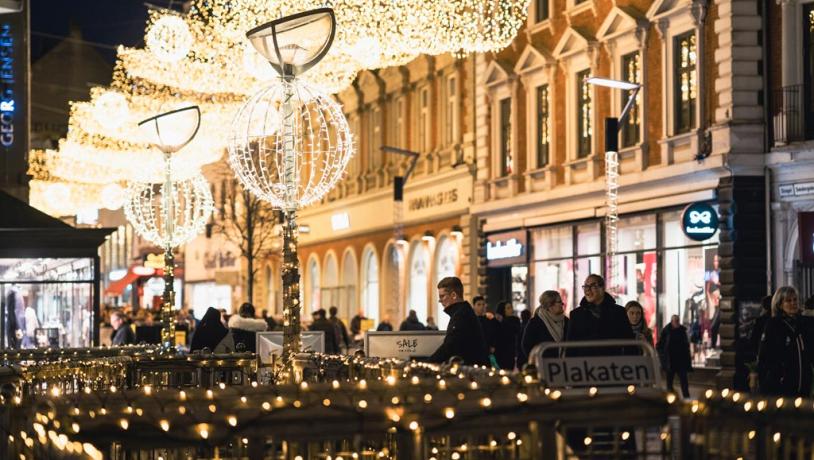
[{"xmin": 365, "ymin": 331, "xmax": 447, "ymax": 360}]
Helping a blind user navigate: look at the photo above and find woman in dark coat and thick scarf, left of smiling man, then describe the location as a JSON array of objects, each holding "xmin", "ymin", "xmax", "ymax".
[{"xmin": 520, "ymin": 291, "xmax": 568, "ymax": 359}]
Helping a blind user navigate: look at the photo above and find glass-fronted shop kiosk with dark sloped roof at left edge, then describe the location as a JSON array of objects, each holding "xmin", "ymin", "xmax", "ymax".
[{"xmin": 0, "ymin": 192, "xmax": 115, "ymax": 348}]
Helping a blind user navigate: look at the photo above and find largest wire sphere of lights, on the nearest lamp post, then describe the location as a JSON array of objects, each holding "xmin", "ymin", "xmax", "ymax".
[{"xmin": 228, "ymin": 78, "xmax": 354, "ymax": 209}]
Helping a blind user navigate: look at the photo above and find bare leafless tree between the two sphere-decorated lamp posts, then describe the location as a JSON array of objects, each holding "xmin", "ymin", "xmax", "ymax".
[{"xmin": 211, "ymin": 165, "xmax": 282, "ymax": 303}]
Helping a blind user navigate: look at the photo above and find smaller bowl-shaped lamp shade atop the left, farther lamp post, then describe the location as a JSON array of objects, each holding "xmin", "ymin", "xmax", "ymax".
[{"xmin": 139, "ymin": 105, "xmax": 201, "ymax": 153}]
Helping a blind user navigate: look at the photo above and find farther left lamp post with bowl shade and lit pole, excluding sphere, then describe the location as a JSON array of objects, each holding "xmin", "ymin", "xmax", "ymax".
[{"xmin": 138, "ymin": 106, "xmax": 204, "ymax": 352}]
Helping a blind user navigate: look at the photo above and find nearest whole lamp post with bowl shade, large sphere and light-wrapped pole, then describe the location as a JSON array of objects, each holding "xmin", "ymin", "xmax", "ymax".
[{"xmin": 229, "ymin": 8, "xmax": 353, "ymax": 366}]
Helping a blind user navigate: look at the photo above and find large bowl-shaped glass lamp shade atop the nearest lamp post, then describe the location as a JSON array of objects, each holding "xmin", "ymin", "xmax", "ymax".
[{"xmin": 246, "ymin": 8, "xmax": 336, "ymax": 77}]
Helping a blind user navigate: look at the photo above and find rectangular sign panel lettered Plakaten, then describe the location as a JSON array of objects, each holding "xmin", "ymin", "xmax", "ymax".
[{"xmin": 543, "ymin": 356, "xmax": 656, "ymax": 387}]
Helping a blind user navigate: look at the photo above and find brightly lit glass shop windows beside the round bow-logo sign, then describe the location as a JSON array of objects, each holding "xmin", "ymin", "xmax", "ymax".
[{"xmin": 486, "ymin": 203, "xmax": 720, "ymax": 366}]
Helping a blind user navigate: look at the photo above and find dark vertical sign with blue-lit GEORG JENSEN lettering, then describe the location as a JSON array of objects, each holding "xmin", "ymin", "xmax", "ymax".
[{"xmin": 0, "ymin": 5, "xmax": 29, "ymax": 201}]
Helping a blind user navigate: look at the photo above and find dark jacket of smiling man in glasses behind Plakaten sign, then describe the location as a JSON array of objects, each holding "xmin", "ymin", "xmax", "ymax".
[{"xmin": 566, "ymin": 293, "xmax": 635, "ymax": 356}]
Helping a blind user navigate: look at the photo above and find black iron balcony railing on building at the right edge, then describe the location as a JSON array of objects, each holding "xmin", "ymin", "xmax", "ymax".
[{"xmin": 772, "ymin": 85, "xmax": 811, "ymax": 146}]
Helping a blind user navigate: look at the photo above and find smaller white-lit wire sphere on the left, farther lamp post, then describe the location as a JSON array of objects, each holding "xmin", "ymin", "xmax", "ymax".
[{"xmin": 124, "ymin": 173, "xmax": 214, "ymax": 247}]
